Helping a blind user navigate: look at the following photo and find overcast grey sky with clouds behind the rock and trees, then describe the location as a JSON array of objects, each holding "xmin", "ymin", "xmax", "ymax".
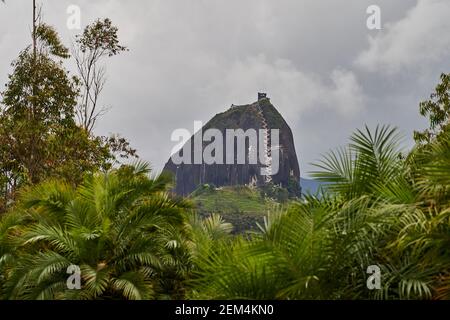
[{"xmin": 0, "ymin": 0, "xmax": 450, "ymax": 176}]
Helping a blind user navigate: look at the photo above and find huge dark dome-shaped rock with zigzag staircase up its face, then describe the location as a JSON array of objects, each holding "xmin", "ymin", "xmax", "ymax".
[{"xmin": 164, "ymin": 95, "xmax": 301, "ymax": 196}]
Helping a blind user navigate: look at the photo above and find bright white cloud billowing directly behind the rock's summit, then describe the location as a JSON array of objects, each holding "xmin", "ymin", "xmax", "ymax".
[{"xmin": 203, "ymin": 55, "xmax": 365, "ymax": 122}]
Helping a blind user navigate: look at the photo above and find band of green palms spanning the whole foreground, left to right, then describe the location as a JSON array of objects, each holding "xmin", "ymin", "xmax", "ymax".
[{"xmin": 0, "ymin": 127, "xmax": 450, "ymax": 299}]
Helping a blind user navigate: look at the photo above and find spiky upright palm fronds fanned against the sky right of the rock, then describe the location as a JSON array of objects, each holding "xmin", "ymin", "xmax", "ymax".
[{"xmin": 311, "ymin": 126, "xmax": 402, "ymax": 199}]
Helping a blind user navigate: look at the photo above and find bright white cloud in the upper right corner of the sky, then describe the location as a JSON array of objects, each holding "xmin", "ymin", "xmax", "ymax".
[{"xmin": 357, "ymin": 0, "xmax": 450, "ymax": 74}]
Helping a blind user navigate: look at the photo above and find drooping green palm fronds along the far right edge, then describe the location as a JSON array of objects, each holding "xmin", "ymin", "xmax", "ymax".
[{"xmin": 384, "ymin": 131, "xmax": 450, "ymax": 299}]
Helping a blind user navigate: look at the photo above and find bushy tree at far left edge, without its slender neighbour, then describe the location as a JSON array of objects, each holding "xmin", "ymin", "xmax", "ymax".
[{"xmin": 0, "ymin": 33, "xmax": 111, "ymax": 211}]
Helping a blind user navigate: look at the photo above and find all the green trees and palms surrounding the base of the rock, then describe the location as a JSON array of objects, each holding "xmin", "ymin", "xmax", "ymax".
[{"xmin": 0, "ymin": 5, "xmax": 450, "ymax": 299}]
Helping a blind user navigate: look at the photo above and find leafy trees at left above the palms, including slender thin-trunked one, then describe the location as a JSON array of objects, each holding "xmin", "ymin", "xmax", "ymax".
[{"xmin": 0, "ymin": 13, "xmax": 137, "ymax": 213}]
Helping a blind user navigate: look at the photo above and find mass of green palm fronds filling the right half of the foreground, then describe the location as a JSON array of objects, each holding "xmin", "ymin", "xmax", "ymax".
[{"xmin": 189, "ymin": 126, "xmax": 450, "ymax": 299}]
